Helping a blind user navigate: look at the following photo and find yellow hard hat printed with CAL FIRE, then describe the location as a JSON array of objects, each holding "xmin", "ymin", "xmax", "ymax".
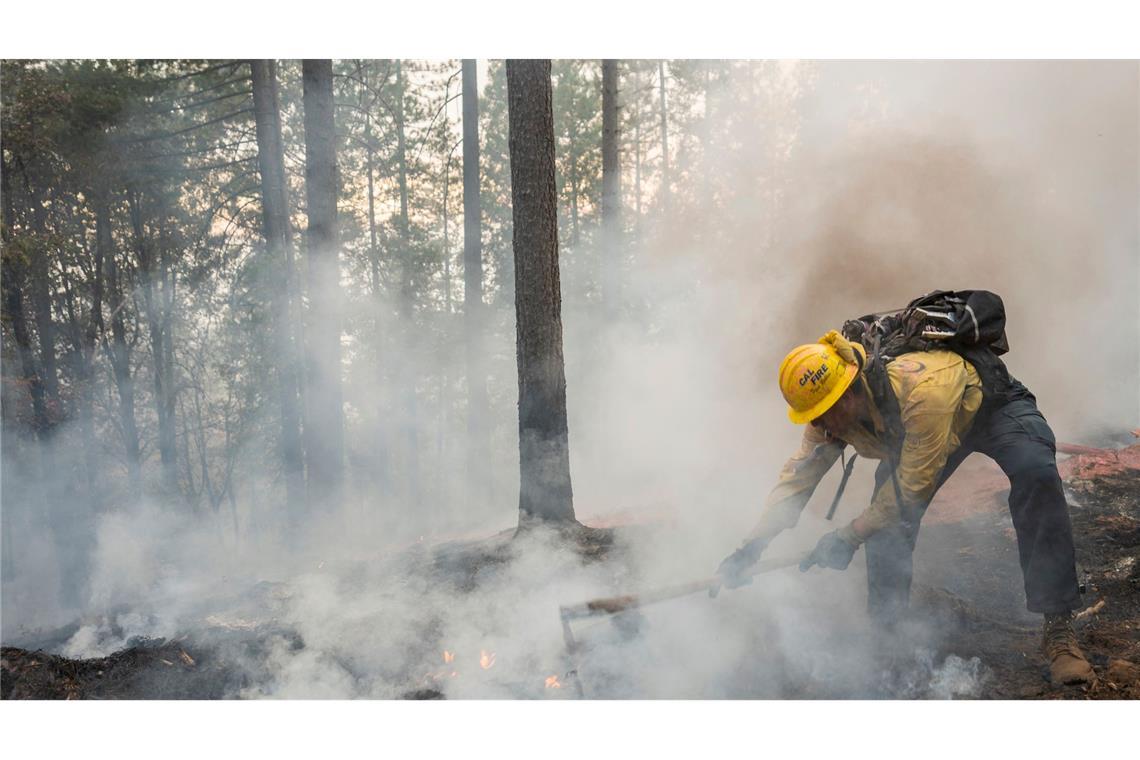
[{"xmin": 780, "ymin": 343, "xmax": 862, "ymax": 425}]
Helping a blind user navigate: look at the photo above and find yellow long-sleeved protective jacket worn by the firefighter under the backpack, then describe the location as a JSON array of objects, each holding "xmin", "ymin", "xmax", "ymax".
[{"xmin": 749, "ymin": 351, "xmax": 982, "ymax": 540}]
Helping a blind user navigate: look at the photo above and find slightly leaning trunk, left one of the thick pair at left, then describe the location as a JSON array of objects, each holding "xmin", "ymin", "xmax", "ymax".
[{"xmin": 250, "ymin": 60, "xmax": 303, "ymax": 518}]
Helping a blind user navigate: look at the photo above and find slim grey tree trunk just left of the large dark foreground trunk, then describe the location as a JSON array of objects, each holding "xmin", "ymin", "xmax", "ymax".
[{"xmin": 463, "ymin": 59, "xmax": 490, "ymax": 495}]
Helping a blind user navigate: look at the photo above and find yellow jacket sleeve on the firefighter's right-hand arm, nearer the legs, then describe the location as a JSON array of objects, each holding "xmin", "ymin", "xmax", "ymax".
[{"xmin": 856, "ymin": 373, "xmax": 967, "ymax": 538}]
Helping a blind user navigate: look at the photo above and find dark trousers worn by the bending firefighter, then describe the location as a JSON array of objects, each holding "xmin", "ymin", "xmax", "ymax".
[{"xmin": 864, "ymin": 394, "xmax": 1081, "ymax": 623}]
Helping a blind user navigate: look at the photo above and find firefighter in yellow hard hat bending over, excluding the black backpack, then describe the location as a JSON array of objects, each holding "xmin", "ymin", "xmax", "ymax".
[{"xmin": 717, "ymin": 330, "xmax": 1093, "ymax": 684}]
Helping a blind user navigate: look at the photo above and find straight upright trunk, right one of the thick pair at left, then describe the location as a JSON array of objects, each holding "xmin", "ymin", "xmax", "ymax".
[{"xmin": 301, "ymin": 60, "xmax": 344, "ymax": 507}]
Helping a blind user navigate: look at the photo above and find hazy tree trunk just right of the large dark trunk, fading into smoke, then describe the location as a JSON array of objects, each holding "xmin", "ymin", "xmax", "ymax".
[{"xmin": 601, "ymin": 58, "xmax": 621, "ymax": 312}]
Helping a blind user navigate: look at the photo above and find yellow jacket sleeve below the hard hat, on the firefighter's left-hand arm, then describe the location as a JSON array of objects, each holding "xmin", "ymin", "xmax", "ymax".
[{"xmin": 747, "ymin": 425, "xmax": 844, "ymax": 541}]
